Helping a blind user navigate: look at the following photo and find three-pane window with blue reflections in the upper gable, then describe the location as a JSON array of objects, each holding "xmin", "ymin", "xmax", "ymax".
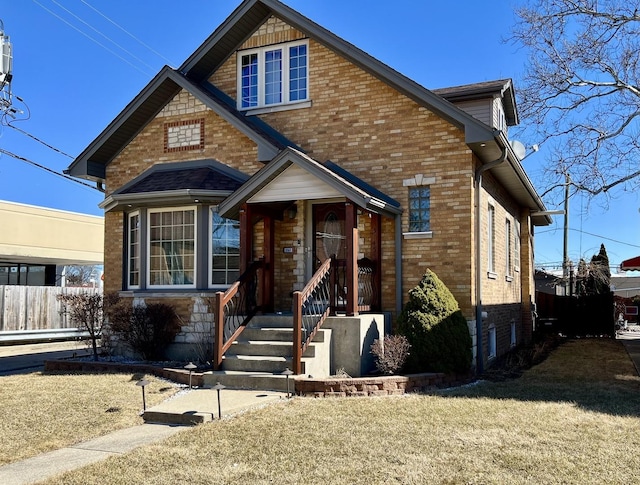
[{"xmin": 238, "ymin": 40, "xmax": 309, "ymax": 110}]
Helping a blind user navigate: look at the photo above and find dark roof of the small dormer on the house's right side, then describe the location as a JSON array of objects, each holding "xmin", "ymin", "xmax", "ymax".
[{"xmin": 433, "ymin": 79, "xmax": 519, "ymax": 126}]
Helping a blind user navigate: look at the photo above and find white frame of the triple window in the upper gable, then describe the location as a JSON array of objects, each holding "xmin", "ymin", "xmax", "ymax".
[{"xmin": 236, "ymin": 39, "xmax": 311, "ymax": 110}]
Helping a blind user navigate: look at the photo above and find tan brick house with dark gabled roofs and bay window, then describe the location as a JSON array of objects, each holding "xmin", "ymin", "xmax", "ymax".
[{"xmin": 68, "ymin": 0, "xmax": 550, "ymax": 378}]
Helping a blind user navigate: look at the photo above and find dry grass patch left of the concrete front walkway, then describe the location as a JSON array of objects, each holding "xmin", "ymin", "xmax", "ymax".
[{"xmin": 0, "ymin": 372, "xmax": 177, "ymax": 465}]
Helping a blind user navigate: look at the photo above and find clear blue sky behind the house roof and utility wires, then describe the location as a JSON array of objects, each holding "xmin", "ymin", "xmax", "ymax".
[{"xmin": 0, "ymin": 0, "xmax": 640, "ymax": 269}]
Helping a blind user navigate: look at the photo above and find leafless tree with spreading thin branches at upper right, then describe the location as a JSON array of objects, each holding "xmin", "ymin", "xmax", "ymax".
[{"xmin": 511, "ymin": 0, "xmax": 640, "ymax": 202}]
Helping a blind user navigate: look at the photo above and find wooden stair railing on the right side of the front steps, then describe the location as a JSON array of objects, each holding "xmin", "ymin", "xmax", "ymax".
[{"xmin": 293, "ymin": 259, "xmax": 336, "ymax": 374}]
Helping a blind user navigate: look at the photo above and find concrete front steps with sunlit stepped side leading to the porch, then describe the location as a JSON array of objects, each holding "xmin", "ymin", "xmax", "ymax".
[{"xmin": 203, "ymin": 315, "xmax": 331, "ymax": 392}]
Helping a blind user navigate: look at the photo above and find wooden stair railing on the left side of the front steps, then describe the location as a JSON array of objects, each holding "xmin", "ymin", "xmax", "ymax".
[{"xmin": 213, "ymin": 260, "xmax": 264, "ymax": 370}]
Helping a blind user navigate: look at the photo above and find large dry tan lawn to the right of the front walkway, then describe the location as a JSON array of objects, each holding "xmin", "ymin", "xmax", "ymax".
[{"xmin": 41, "ymin": 340, "xmax": 640, "ymax": 485}]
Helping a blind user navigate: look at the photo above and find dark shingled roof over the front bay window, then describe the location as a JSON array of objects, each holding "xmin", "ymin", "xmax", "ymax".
[{"xmin": 100, "ymin": 160, "xmax": 249, "ymax": 211}]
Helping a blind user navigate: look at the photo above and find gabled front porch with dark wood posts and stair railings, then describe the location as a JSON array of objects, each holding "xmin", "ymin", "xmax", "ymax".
[{"xmin": 213, "ymin": 148, "xmax": 402, "ymax": 377}]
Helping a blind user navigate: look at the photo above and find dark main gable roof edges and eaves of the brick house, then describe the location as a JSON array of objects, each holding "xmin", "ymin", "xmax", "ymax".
[{"xmin": 66, "ymin": 0, "xmax": 551, "ymax": 225}]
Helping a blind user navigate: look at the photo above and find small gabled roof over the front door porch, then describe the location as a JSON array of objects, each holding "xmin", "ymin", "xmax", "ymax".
[{"xmin": 218, "ymin": 147, "xmax": 402, "ymax": 218}]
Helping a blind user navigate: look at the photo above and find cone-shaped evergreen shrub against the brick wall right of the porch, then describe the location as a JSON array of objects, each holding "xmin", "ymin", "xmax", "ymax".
[{"xmin": 397, "ymin": 270, "xmax": 472, "ymax": 373}]
